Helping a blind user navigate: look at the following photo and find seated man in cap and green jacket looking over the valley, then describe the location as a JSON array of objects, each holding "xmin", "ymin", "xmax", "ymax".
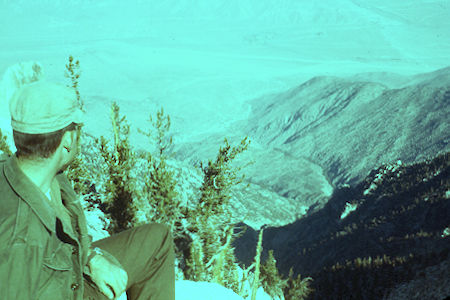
[{"xmin": 0, "ymin": 80, "xmax": 175, "ymax": 300}]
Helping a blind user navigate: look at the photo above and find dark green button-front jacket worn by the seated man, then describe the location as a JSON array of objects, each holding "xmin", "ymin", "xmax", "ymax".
[{"xmin": 0, "ymin": 154, "xmax": 118, "ymax": 300}]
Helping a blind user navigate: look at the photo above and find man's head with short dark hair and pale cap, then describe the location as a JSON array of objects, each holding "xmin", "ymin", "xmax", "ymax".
[{"xmin": 9, "ymin": 80, "xmax": 84, "ymax": 169}]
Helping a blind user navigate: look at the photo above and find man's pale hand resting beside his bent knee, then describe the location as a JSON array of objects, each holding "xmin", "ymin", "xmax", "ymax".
[{"xmin": 89, "ymin": 255, "xmax": 128, "ymax": 300}]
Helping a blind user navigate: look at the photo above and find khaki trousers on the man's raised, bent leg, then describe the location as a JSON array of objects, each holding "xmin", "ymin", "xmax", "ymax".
[{"xmin": 84, "ymin": 224, "xmax": 175, "ymax": 300}]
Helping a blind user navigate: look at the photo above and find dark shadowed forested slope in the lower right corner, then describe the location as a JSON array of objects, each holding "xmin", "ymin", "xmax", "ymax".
[{"xmin": 236, "ymin": 152, "xmax": 450, "ymax": 299}]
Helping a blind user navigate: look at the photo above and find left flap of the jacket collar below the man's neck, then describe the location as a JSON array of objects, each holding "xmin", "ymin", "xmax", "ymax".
[{"xmin": 3, "ymin": 155, "xmax": 56, "ymax": 233}]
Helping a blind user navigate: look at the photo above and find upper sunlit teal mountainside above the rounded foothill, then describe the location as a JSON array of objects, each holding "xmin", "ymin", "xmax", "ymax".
[{"xmin": 244, "ymin": 68, "xmax": 450, "ymax": 190}]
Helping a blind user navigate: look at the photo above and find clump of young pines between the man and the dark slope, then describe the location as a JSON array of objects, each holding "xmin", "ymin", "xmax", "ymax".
[{"xmin": 60, "ymin": 57, "xmax": 316, "ymax": 299}]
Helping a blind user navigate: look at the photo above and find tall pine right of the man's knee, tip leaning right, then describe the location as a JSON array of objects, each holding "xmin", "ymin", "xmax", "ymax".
[{"xmin": 185, "ymin": 138, "xmax": 253, "ymax": 293}]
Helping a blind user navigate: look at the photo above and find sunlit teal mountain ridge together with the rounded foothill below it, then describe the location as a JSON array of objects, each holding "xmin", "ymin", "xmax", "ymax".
[{"xmin": 176, "ymin": 68, "xmax": 450, "ymax": 228}]
